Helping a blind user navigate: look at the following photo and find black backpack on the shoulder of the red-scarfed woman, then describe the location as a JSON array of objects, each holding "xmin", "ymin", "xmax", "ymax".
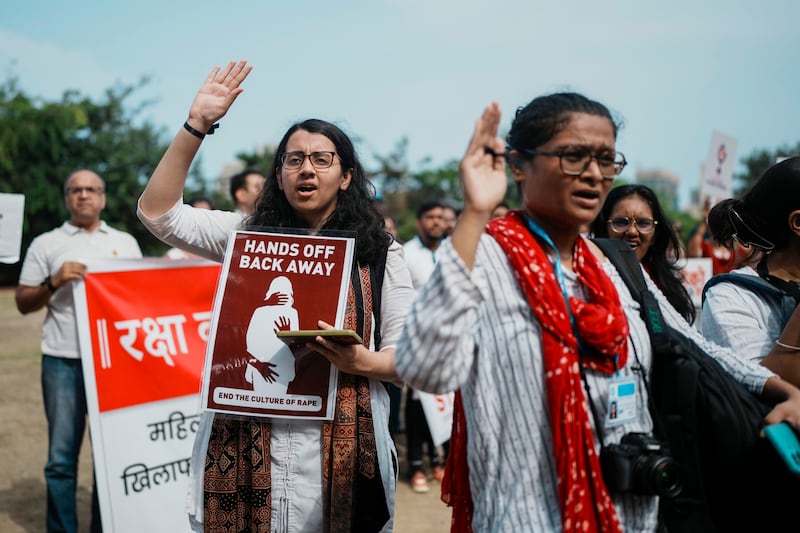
[{"xmin": 594, "ymin": 239, "xmax": 800, "ymax": 533}]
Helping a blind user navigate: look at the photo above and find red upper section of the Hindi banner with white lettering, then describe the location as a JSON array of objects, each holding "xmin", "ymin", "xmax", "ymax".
[{"xmin": 85, "ymin": 263, "xmax": 220, "ymax": 413}]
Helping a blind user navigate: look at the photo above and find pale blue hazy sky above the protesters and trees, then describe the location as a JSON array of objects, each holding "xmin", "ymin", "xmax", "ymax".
[{"xmin": 0, "ymin": 0, "xmax": 800, "ymax": 207}]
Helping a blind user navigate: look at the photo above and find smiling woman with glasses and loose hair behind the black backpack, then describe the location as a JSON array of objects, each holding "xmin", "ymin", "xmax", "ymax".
[{"xmin": 591, "ymin": 185, "xmax": 696, "ymax": 324}]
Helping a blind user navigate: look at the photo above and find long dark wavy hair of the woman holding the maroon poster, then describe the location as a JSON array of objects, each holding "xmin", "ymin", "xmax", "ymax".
[{"xmin": 245, "ymin": 119, "xmax": 392, "ymax": 264}]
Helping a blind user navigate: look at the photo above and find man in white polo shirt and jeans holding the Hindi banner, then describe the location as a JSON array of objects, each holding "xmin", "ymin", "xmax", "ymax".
[{"xmin": 15, "ymin": 169, "xmax": 142, "ymax": 533}]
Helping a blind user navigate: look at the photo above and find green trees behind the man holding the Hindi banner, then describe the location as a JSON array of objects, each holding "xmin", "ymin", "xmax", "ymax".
[{"xmin": 0, "ymin": 78, "xmax": 176, "ymax": 282}]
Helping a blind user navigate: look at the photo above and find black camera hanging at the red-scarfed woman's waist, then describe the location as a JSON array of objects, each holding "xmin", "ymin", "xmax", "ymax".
[{"xmin": 600, "ymin": 433, "xmax": 683, "ymax": 498}]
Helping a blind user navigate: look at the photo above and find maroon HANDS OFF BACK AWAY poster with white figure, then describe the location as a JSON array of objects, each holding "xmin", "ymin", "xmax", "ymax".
[{"xmin": 202, "ymin": 230, "xmax": 355, "ymax": 420}]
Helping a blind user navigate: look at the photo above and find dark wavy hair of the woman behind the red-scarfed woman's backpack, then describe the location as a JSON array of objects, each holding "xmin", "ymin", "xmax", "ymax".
[{"xmin": 590, "ymin": 185, "xmax": 697, "ymax": 323}]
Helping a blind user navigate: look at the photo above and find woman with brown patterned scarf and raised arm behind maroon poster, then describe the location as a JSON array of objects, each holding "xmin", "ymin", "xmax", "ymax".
[{"xmin": 138, "ymin": 61, "xmax": 414, "ymax": 533}]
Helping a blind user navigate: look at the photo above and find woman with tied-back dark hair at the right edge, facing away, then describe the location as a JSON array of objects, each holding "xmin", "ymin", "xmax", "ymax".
[{"xmin": 702, "ymin": 157, "xmax": 800, "ymax": 385}]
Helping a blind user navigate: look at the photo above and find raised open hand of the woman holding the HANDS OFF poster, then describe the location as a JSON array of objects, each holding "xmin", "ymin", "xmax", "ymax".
[{"xmin": 187, "ymin": 60, "xmax": 253, "ymax": 131}]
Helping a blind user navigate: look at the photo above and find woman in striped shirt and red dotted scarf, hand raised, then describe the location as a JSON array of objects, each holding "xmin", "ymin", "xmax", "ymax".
[{"xmin": 397, "ymin": 93, "xmax": 800, "ymax": 533}]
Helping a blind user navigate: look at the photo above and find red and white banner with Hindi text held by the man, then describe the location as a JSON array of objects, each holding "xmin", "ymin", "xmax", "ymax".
[{"xmin": 73, "ymin": 259, "xmax": 220, "ymax": 533}]
